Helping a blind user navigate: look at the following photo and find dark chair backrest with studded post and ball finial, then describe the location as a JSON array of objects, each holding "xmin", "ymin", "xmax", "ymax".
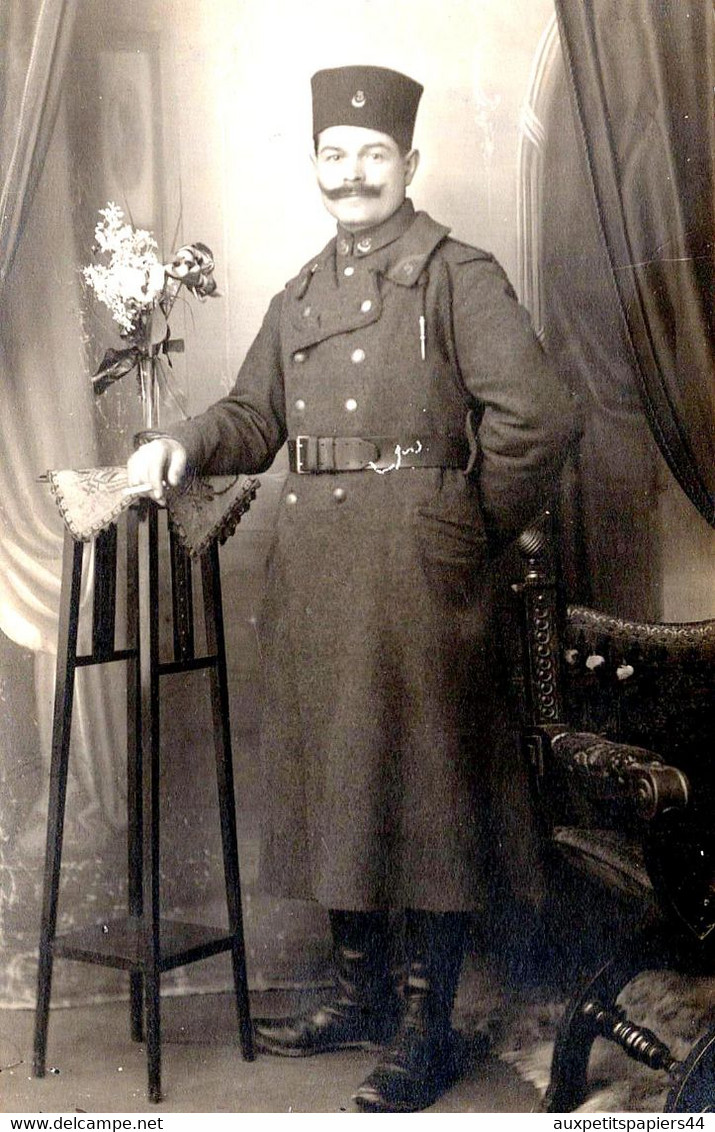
[{"xmin": 515, "ymin": 516, "xmax": 715, "ymax": 827}]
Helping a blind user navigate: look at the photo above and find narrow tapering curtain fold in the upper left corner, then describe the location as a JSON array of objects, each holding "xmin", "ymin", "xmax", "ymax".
[{"xmin": 0, "ymin": 0, "xmax": 78, "ymax": 288}]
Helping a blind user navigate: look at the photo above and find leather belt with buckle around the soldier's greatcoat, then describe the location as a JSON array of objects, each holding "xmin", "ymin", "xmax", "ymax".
[{"xmin": 288, "ymin": 436, "xmax": 472, "ymax": 475}]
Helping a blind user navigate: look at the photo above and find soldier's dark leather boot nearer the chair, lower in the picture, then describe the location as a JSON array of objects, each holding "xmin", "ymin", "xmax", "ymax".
[{"xmin": 353, "ymin": 911, "xmax": 466, "ymax": 1113}]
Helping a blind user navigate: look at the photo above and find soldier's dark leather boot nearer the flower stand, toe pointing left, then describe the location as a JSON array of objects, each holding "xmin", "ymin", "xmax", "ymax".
[{"xmin": 255, "ymin": 911, "xmax": 400, "ymax": 1057}]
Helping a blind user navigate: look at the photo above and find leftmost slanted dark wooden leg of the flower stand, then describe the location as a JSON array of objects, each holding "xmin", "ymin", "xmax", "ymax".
[{"xmin": 33, "ymin": 532, "xmax": 84, "ymax": 1077}]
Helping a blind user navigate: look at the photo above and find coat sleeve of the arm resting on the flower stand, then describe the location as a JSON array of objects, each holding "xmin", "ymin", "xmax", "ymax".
[{"xmin": 167, "ymin": 294, "xmax": 286, "ymax": 475}]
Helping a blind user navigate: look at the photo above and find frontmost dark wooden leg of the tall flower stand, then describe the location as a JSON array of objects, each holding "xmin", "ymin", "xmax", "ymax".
[{"xmin": 138, "ymin": 507, "xmax": 162, "ymax": 1104}]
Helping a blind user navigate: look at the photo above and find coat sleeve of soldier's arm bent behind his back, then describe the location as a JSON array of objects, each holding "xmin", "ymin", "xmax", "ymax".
[{"xmin": 450, "ymin": 256, "xmax": 575, "ymax": 546}]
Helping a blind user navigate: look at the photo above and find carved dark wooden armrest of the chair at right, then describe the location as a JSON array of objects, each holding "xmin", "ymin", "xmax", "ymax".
[{"xmin": 541, "ymin": 727, "xmax": 690, "ymax": 821}]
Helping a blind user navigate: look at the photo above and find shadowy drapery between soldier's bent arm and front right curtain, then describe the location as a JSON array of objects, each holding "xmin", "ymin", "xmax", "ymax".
[{"xmin": 540, "ymin": 58, "xmax": 665, "ymax": 620}]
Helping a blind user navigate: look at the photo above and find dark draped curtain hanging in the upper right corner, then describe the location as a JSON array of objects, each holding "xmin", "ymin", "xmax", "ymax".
[{"xmin": 555, "ymin": 0, "xmax": 715, "ymax": 526}]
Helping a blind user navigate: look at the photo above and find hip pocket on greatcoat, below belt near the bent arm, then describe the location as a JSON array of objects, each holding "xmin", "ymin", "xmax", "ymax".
[{"xmin": 414, "ymin": 479, "xmax": 486, "ymax": 606}]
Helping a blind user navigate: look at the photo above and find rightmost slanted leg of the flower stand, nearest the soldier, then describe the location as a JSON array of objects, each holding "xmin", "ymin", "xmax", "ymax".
[{"xmin": 201, "ymin": 542, "xmax": 256, "ymax": 1061}]
